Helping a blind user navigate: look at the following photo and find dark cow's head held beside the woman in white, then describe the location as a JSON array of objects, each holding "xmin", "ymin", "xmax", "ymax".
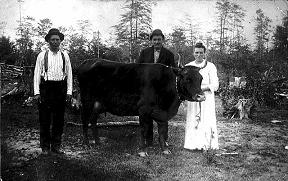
[{"xmin": 174, "ymin": 66, "xmax": 205, "ymax": 102}]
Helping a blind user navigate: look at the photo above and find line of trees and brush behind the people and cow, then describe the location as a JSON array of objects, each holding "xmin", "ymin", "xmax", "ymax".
[{"xmin": 0, "ymin": 0, "xmax": 288, "ymax": 107}]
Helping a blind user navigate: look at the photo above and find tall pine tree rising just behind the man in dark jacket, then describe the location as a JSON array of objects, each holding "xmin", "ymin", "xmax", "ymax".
[{"xmin": 113, "ymin": 0, "xmax": 155, "ymax": 62}]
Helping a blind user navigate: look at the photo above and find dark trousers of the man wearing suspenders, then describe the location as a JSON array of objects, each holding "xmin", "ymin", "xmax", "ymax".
[{"xmin": 39, "ymin": 79, "xmax": 67, "ymax": 150}]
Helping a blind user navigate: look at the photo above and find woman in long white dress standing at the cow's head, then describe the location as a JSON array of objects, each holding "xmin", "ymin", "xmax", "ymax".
[{"xmin": 184, "ymin": 43, "xmax": 219, "ymax": 150}]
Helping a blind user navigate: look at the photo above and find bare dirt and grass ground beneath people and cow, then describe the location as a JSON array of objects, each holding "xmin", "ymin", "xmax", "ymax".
[{"xmin": 1, "ymin": 98, "xmax": 288, "ymax": 181}]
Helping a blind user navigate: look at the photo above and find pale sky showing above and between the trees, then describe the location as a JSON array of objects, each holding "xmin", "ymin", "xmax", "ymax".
[{"xmin": 0, "ymin": 0, "xmax": 288, "ymax": 43}]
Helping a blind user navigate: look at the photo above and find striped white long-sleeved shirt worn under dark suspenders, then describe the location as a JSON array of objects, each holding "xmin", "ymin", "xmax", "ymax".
[{"xmin": 34, "ymin": 50, "xmax": 72, "ymax": 95}]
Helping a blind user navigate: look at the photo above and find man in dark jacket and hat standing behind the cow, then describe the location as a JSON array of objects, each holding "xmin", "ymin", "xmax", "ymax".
[{"xmin": 137, "ymin": 29, "xmax": 176, "ymax": 146}]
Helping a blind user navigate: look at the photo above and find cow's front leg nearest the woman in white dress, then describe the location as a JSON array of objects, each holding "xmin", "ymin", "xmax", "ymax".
[{"xmin": 157, "ymin": 121, "xmax": 171, "ymax": 154}]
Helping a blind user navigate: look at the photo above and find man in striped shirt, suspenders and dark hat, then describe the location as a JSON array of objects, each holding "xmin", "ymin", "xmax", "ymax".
[{"xmin": 34, "ymin": 28, "xmax": 72, "ymax": 155}]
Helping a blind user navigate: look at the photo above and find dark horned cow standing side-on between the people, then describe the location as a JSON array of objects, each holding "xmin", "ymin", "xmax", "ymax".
[{"xmin": 78, "ymin": 59, "xmax": 204, "ymax": 155}]
